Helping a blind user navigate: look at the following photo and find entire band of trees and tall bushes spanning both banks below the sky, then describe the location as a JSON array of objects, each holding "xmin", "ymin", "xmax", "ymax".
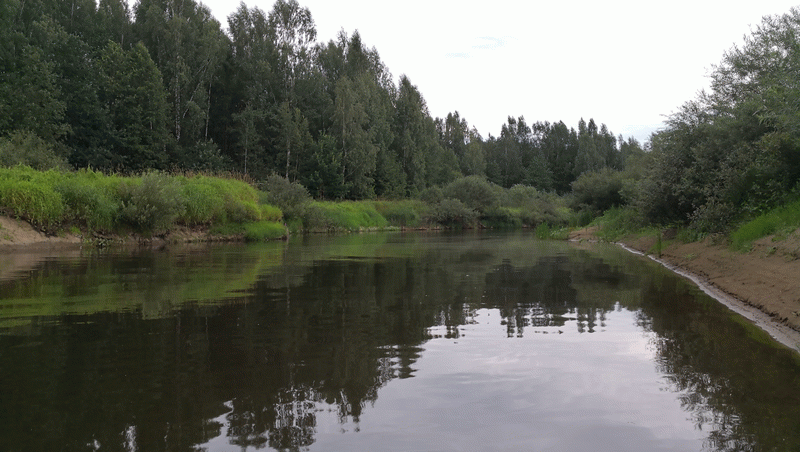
[{"xmin": 0, "ymin": 0, "xmax": 800, "ymax": 238}]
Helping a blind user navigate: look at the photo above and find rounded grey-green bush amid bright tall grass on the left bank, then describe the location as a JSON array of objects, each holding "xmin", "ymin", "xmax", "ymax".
[{"xmin": 119, "ymin": 172, "xmax": 185, "ymax": 234}]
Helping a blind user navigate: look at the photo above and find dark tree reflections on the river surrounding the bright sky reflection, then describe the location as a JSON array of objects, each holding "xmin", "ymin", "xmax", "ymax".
[{"xmin": 0, "ymin": 237, "xmax": 800, "ymax": 451}]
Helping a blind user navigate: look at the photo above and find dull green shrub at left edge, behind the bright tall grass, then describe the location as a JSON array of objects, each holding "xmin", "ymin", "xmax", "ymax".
[{"xmin": 0, "ymin": 130, "xmax": 67, "ymax": 171}]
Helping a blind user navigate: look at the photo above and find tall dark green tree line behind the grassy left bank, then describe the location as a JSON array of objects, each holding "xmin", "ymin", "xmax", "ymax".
[{"xmin": 0, "ymin": 0, "xmax": 641, "ymax": 199}]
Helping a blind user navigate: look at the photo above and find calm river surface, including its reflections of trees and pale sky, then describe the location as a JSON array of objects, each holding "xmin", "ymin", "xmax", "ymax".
[{"xmin": 0, "ymin": 232, "xmax": 800, "ymax": 452}]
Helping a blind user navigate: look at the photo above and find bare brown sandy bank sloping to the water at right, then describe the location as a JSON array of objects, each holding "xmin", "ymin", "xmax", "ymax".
[{"xmin": 569, "ymin": 228, "xmax": 800, "ymax": 350}]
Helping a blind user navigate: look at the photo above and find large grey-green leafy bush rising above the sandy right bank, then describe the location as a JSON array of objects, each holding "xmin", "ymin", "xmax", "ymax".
[{"xmin": 637, "ymin": 9, "xmax": 800, "ymax": 233}]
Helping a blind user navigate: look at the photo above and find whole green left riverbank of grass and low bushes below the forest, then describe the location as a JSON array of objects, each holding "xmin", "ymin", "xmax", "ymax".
[{"xmin": 0, "ymin": 166, "xmax": 576, "ymax": 243}]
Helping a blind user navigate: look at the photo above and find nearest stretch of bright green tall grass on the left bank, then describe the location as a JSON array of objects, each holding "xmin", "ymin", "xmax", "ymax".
[{"xmin": 0, "ymin": 166, "xmax": 283, "ymax": 237}]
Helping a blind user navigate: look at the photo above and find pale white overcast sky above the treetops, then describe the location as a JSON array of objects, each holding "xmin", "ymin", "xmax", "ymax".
[{"xmin": 200, "ymin": 0, "xmax": 797, "ymax": 143}]
